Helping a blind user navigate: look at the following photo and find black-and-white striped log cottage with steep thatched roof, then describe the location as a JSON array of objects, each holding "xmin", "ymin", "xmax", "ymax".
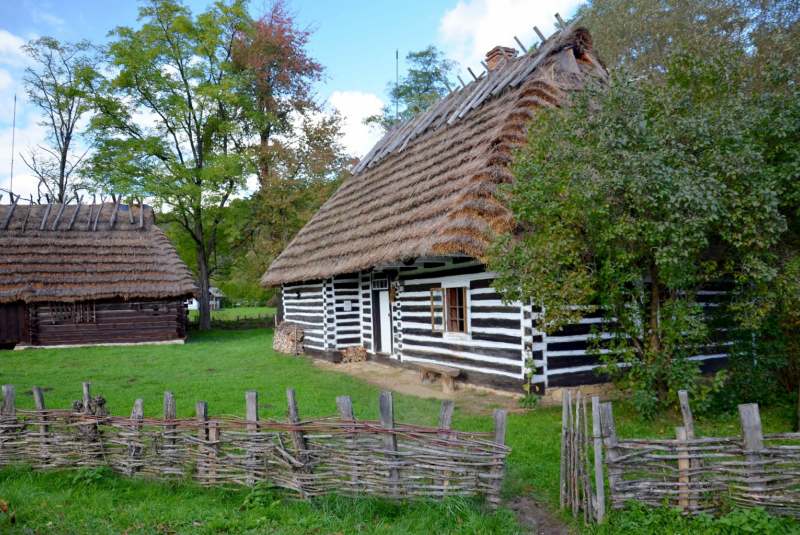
[{"xmin": 261, "ymin": 24, "xmax": 728, "ymax": 393}]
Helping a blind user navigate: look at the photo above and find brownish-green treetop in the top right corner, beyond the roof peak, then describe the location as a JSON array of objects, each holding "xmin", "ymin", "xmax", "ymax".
[{"xmin": 577, "ymin": 0, "xmax": 800, "ymax": 82}]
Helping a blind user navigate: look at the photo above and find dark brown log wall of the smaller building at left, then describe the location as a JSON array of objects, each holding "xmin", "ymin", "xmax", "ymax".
[{"xmin": 28, "ymin": 299, "xmax": 187, "ymax": 346}]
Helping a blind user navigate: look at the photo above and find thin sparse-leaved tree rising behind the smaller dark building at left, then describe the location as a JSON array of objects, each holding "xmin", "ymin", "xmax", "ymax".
[{"xmin": 22, "ymin": 37, "xmax": 97, "ymax": 203}]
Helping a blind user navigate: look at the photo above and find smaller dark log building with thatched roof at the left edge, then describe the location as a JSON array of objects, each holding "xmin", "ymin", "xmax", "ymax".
[{"xmin": 0, "ymin": 200, "xmax": 197, "ymax": 349}]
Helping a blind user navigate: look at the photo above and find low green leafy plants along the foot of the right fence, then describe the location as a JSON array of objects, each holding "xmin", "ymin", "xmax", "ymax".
[{"xmin": 589, "ymin": 502, "xmax": 800, "ymax": 535}]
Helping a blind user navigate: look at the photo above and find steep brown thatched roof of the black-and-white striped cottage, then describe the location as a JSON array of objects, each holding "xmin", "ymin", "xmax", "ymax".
[{"xmin": 261, "ymin": 28, "xmax": 608, "ymax": 286}]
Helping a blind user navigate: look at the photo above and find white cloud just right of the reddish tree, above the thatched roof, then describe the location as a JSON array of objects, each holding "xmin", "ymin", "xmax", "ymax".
[{"xmin": 328, "ymin": 91, "xmax": 383, "ymax": 158}]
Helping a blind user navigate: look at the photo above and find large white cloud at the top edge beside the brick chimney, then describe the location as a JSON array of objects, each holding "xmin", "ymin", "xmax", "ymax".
[{"xmin": 439, "ymin": 0, "xmax": 582, "ymax": 74}]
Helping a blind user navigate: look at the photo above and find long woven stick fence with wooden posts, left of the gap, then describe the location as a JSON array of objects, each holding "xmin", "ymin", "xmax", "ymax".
[{"xmin": 0, "ymin": 383, "xmax": 510, "ymax": 506}]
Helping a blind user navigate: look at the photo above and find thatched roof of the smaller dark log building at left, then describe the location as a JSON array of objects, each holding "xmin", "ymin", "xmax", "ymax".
[{"xmin": 0, "ymin": 203, "xmax": 197, "ymax": 303}]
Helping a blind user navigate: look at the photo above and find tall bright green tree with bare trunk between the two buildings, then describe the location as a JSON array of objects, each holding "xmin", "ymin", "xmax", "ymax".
[{"xmin": 88, "ymin": 0, "xmax": 251, "ymax": 329}]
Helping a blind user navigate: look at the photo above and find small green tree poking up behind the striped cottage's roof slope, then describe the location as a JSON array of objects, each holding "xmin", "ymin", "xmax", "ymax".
[{"xmin": 364, "ymin": 45, "xmax": 458, "ymax": 127}]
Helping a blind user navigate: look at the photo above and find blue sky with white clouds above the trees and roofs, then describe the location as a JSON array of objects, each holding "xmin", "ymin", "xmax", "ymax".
[{"xmin": 0, "ymin": 0, "xmax": 581, "ymax": 202}]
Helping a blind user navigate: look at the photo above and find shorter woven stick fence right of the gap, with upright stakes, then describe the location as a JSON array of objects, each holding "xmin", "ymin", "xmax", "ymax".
[{"xmin": 560, "ymin": 391, "xmax": 800, "ymax": 523}]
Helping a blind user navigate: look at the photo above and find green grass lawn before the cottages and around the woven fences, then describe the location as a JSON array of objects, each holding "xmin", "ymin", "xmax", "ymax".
[{"xmin": 0, "ymin": 328, "xmax": 793, "ymax": 535}]
